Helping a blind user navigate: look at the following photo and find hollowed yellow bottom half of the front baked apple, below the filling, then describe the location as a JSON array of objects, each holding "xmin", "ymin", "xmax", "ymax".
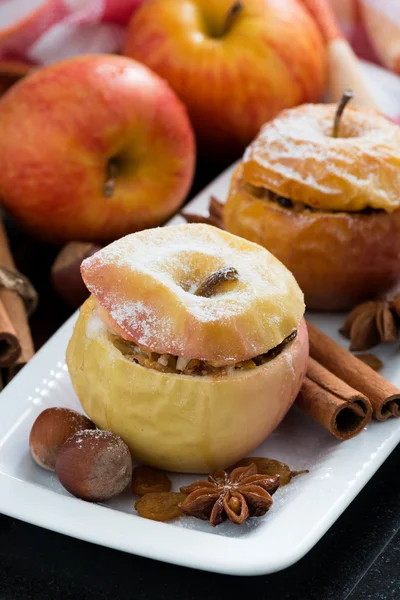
[{"xmin": 67, "ymin": 298, "xmax": 308, "ymax": 473}]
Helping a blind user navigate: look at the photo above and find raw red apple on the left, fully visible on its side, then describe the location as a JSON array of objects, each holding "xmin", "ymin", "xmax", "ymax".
[{"xmin": 0, "ymin": 55, "xmax": 195, "ymax": 244}]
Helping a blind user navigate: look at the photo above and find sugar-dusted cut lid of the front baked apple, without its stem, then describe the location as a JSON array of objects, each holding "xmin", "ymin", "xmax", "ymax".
[{"xmin": 82, "ymin": 224, "xmax": 304, "ymax": 364}]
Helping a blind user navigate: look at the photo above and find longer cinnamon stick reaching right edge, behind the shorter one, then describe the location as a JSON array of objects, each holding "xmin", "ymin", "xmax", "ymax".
[{"xmin": 307, "ymin": 322, "xmax": 400, "ymax": 421}]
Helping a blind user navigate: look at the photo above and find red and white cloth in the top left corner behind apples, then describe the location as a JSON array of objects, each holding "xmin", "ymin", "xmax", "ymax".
[{"xmin": 0, "ymin": 0, "xmax": 143, "ymax": 64}]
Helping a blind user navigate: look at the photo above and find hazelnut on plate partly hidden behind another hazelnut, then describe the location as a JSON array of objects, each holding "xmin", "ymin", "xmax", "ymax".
[{"xmin": 29, "ymin": 407, "xmax": 96, "ymax": 471}]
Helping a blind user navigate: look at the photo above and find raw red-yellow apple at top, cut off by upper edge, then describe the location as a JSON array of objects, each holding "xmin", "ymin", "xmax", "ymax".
[{"xmin": 124, "ymin": 0, "xmax": 325, "ymax": 158}]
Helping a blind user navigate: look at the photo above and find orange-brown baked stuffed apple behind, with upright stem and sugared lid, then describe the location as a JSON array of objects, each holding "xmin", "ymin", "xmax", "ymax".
[{"xmin": 223, "ymin": 98, "xmax": 400, "ymax": 310}]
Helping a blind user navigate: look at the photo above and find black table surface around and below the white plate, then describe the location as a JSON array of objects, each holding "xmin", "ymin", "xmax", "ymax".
[{"xmin": 0, "ymin": 165, "xmax": 400, "ymax": 600}]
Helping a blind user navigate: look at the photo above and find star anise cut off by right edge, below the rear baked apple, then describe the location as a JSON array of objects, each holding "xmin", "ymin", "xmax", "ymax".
[{"xmin": 340, "ymin": 296, "xmax": 400, "ymax": 351}]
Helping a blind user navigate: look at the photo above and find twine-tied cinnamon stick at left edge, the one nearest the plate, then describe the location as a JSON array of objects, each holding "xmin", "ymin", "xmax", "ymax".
[{"xmin": 0, "ymin": 219, "xmax": 34, "ymax": 366}]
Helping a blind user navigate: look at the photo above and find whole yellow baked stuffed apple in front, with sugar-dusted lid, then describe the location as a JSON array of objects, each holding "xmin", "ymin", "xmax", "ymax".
[{"xmin": 67, "ymin": 224, "xmax": 308, "ymax": 472}]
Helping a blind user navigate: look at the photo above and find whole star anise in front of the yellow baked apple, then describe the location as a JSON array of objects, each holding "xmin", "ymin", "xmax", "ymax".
[{"xmin": 180, "ymin": 463, "xmax": 279, "ymax": 527}]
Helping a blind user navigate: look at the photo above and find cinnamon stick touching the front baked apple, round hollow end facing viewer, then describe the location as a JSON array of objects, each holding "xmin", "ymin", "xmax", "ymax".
[{"xmin": 296, "ymin": 358, "xmax": 372, "ymax": 440}]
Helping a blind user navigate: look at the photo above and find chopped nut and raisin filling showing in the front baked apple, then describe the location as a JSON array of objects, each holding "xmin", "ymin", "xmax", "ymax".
[{"xmin": 111, "ymin": 330, "xmax": 297, "ymax": 377}]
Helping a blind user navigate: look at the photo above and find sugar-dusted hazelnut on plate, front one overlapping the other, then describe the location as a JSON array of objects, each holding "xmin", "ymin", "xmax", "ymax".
[{"xmin": 56, "ymin": 430, "xmax": 132, "ymax": 502}]
